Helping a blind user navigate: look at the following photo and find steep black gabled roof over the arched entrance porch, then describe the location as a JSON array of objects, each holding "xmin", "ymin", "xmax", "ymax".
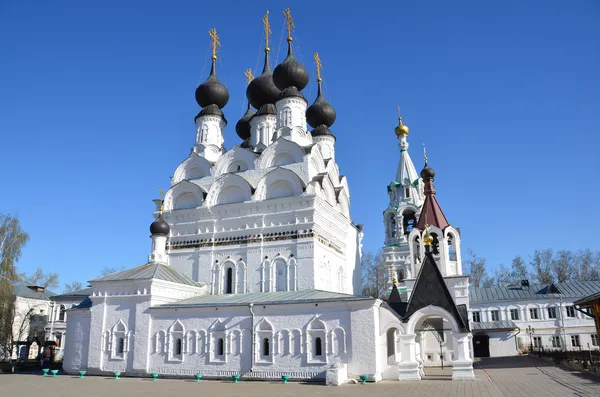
[{"xmin": 399, "ymin": 252, "xmax": 469, "ymax": 331}]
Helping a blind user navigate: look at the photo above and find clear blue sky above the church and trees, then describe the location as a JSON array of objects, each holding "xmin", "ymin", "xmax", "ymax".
[{"xmin": 0, "ymin": 0, "xmax": 600, "ymax": 290}]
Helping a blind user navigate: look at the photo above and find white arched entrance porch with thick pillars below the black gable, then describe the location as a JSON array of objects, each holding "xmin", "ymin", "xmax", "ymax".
[{"xmin": 398, "ymin": 305, "xmax": 475, "ymax": 381}]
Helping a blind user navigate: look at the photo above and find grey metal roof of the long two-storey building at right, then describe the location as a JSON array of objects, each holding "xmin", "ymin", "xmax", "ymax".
[{"xmin": 469, "ymin": 281, "xmax": 600, "ymax": 304}]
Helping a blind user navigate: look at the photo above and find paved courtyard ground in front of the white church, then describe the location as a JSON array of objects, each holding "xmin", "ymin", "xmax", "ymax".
[{"xmin": 0, "ymin": 357, "xmax": 600, "ymax": 397}]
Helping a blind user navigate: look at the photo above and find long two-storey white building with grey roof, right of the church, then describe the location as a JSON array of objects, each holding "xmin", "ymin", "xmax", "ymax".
[{"xmin": 469, "ymin": 280, "xmax": 600, "ymax": 357}]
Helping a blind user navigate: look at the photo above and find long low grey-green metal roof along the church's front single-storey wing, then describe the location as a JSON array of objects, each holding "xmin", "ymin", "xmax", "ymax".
[{"xmin": 154, "ymin": 289, "xmax": 374, "ymax": 308}]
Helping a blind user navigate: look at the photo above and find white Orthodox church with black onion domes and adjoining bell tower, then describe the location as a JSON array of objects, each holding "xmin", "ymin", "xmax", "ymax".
[{"xmin": 63, "ymin": 10, "xmax": 474, "ymax": 384}]
